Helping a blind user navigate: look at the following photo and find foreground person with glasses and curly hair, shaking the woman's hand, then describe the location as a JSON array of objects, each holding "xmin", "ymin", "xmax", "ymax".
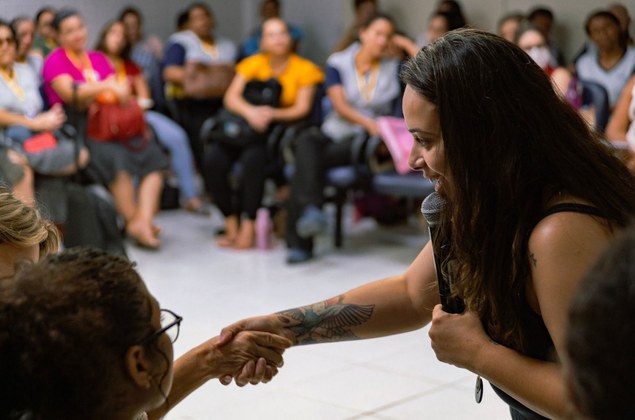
[{"xmin": 0, "ymin": 249, "xmax": 291, "ymax": 420}]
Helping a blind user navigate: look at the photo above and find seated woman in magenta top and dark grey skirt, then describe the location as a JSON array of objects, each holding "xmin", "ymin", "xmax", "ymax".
[{"xmin": 43, "ymin": 9, "xmax": 167, "ymax": 249}]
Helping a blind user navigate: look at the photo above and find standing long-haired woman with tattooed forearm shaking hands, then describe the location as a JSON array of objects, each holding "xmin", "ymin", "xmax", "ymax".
[{"xmin": 217, "ymin": 30, "xmax": 635, "ymax": 419}]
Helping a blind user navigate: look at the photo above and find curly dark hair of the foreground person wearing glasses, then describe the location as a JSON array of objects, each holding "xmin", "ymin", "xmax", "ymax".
[{"xmin": 0, "ymin": 249, "xmax": 158, "ymax": 419}]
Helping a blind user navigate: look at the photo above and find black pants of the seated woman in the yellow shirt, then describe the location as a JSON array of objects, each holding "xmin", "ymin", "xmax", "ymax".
[{"xmin": 203, "ymin": 142, "xmax": 267, "ymax": 220}]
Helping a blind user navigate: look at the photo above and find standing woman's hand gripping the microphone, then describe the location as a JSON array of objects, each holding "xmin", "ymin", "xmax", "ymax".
[{"xmin": 428, "ymin": 305, "xmax": 492, "ymax": 373}]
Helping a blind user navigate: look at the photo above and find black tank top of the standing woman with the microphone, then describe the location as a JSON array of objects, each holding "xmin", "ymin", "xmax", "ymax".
[{"xmin": 492, "ymin": 203, "xmax": 605, "ymax": 420}]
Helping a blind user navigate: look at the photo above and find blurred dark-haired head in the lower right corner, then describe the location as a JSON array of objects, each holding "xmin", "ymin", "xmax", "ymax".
[{"xmin": 564, "ymin": 226, "xmax": 635, "ymax": 420}]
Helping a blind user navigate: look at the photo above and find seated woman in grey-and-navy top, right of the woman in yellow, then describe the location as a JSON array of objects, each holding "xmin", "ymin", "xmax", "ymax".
[{"xmin": 286, "ymin": 14, "xmax": 401, "ymax": 263}]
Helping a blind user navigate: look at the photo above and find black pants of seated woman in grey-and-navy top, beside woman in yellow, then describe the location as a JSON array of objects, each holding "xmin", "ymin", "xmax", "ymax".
[{"xmin": 286, "ymin": 128, "xmax": 352, "ymax": 251}]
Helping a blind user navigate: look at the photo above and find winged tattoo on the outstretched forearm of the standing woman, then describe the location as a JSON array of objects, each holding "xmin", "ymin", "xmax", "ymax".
[{"xmin": 278, "ymin": 296, "xmax": 375, "ymax": 344}]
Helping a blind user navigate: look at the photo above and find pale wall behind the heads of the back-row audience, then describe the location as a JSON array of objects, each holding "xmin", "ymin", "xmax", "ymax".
[{"xmin": 0, "ymin": 0, "xmax": 635, "ymax": 62}]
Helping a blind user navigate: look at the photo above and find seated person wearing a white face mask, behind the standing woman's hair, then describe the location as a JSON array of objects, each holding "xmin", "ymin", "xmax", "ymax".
[{"xmin": 514, "ymin": 25, "xmax": 582, "ymax": 109}]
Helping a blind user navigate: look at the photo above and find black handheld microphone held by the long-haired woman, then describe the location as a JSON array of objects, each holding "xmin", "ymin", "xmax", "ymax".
[{"xmin": 421, "ymin": 192, "xmax": 465, "ymax": 314}]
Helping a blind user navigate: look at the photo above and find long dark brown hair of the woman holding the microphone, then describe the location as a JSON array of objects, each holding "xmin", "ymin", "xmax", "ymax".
[{"xmin": 402, "ymin": 29, "xmax": 635, "ymax": 350}]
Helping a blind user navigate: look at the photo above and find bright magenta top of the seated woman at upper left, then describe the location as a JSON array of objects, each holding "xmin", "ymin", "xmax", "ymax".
[{"xmin": 42, "ymin": 48, "xmax": 115, "ymax": 105}]
